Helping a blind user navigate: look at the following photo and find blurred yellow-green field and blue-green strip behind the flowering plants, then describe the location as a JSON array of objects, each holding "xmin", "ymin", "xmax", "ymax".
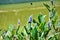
[{"xmin": 0, "ymin": 0, "xmax": 60, "ymax": 37}]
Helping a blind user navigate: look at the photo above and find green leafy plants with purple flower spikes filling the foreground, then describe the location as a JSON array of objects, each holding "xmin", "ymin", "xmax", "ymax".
[{"xmin": 2, "ymin": 0, "xmax": 59, "ymax": 40}]
